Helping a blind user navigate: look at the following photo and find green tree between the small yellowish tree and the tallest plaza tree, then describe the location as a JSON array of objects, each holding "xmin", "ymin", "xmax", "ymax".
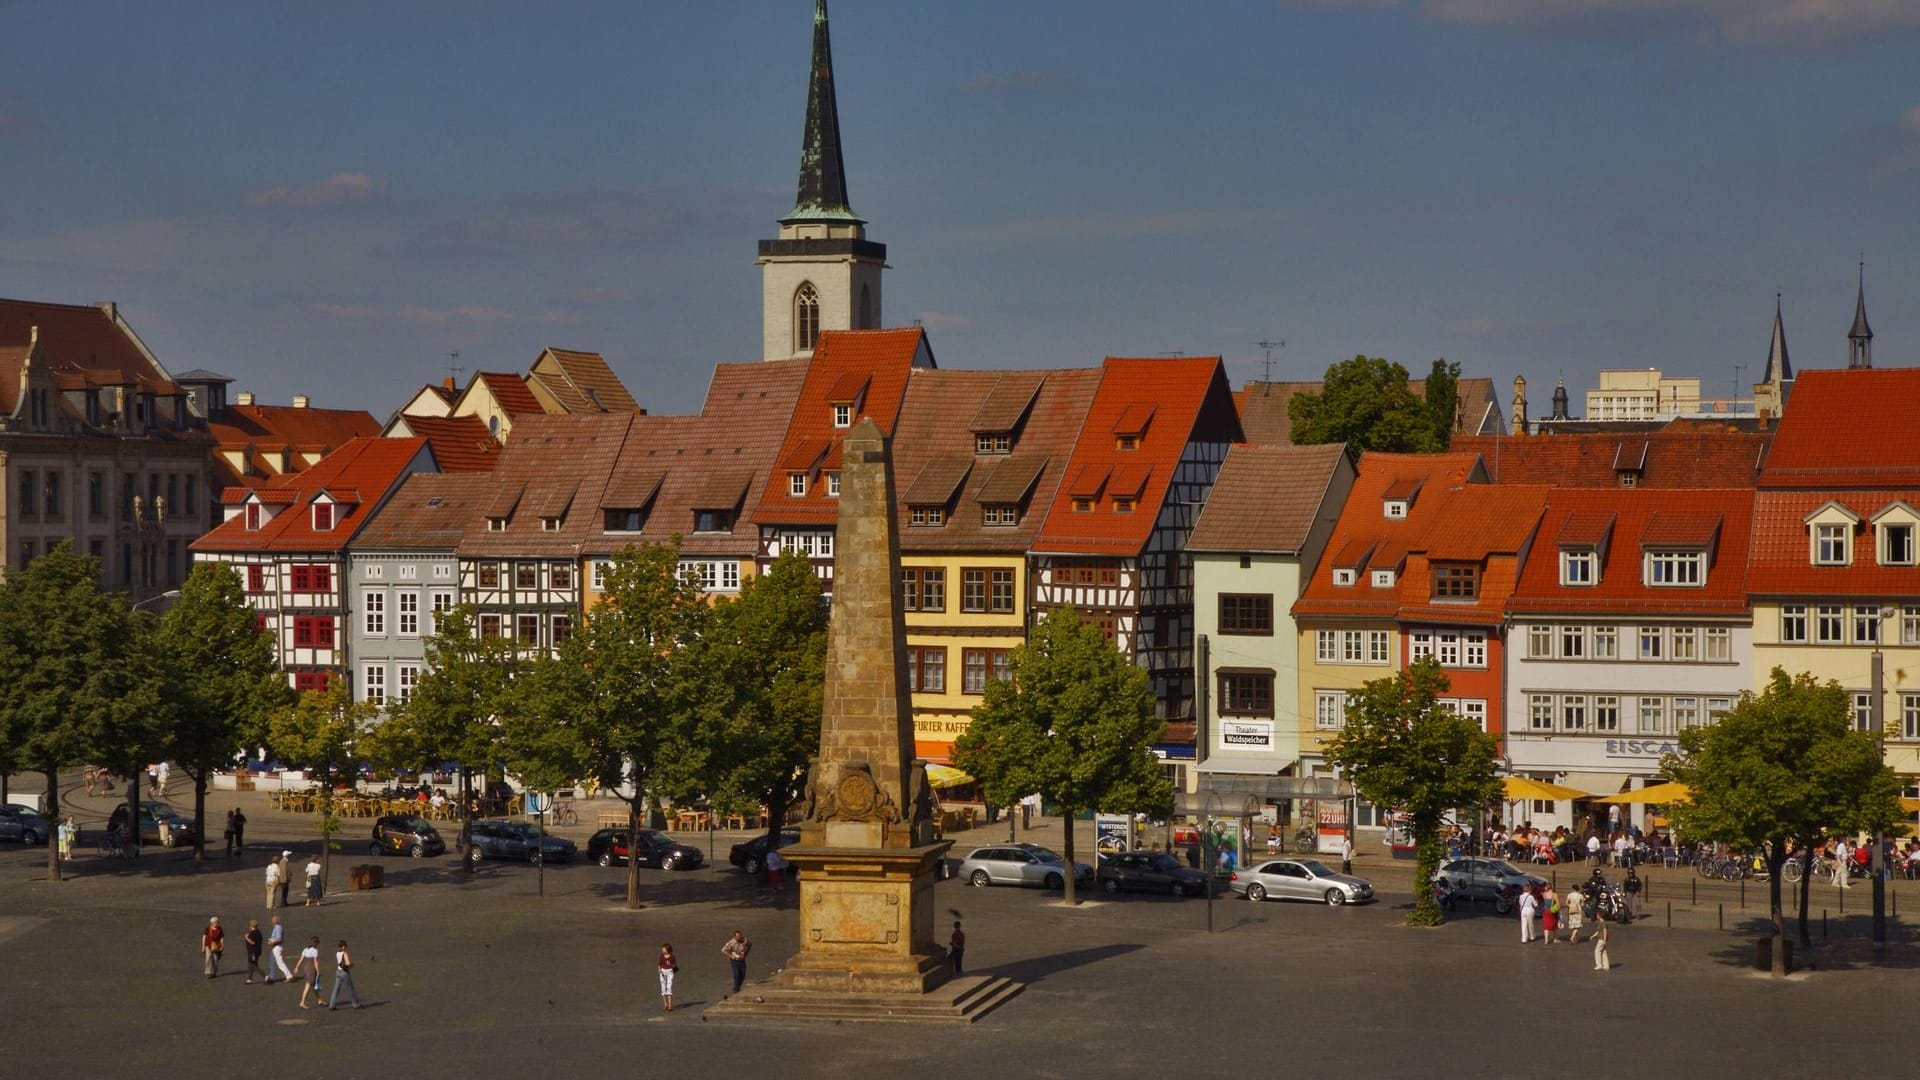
[{"xmin": 365, "ymin": 605, "xmax": 532, "ymax": 872}]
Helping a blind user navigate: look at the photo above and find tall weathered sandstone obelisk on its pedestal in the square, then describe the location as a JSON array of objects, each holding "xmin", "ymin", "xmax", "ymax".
[{"xmin": 764, "ymin": 419, "xmax": 950, "ymax": 994}]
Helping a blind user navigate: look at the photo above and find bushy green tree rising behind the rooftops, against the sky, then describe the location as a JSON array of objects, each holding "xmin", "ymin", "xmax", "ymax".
[{"xmin": 1286, "ymin": 356, "xmax": 1453, "ymax": 457}]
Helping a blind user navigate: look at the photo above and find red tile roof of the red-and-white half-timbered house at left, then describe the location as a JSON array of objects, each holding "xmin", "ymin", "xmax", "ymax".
[{"xmin": 192, "ymin": 438, "xmax": 432, "ymax": 552}]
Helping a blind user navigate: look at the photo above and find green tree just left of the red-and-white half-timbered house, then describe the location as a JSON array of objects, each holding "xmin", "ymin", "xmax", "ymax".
[{"xmin": 150, "ymin": 563, "xmax": 292, "ymax": 863}]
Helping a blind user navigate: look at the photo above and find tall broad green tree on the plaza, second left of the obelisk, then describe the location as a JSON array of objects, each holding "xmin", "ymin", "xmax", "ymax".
[{"xmin": 507, "ymin": 544, "xmax": 712, "ymax": 909}]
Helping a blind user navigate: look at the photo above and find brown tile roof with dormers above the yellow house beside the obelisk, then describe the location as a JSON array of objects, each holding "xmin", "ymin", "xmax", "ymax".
[{"xmin": 893, "ymin": 367, "xmax": 1100, "ymax": 553}]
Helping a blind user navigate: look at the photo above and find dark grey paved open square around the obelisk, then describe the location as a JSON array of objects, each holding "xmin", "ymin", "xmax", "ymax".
[{"xmin": 0, "ymin": 772, "xmax": 1920, "ymax": 1080}]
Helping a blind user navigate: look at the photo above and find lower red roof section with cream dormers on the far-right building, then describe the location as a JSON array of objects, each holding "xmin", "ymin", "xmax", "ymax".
[{"xmin": 1747, "ymin": 488, "xmax": 1920, "ymax": 601}]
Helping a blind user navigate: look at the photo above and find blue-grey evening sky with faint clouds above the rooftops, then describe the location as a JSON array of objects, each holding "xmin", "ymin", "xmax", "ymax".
[{"xmin": 0, "ymin": 0, "xmax": 1920, "ymax": 417}]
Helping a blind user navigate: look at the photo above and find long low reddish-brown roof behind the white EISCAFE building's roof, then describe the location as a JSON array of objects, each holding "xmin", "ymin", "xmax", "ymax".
[{"xmin": 1453, "ymin": 418, "xmax": 1766, "ymax": 488}]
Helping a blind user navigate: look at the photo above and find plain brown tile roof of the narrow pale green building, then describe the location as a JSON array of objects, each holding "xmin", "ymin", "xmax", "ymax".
[{"xmin": 1187, "ymin": 444, "xmax": 1346, "ymax": 553}]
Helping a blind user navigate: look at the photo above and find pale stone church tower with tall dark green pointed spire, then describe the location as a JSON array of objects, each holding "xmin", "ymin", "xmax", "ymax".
[{"xmin": 755, "ymin": 0, "xmax": 887, "ymax": 359}]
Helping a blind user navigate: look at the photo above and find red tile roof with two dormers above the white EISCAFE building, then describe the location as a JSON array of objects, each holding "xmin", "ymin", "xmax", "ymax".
[{"xmin": 1507, "ymin": 488, "xmax": 1758, "ymax": 615}]
